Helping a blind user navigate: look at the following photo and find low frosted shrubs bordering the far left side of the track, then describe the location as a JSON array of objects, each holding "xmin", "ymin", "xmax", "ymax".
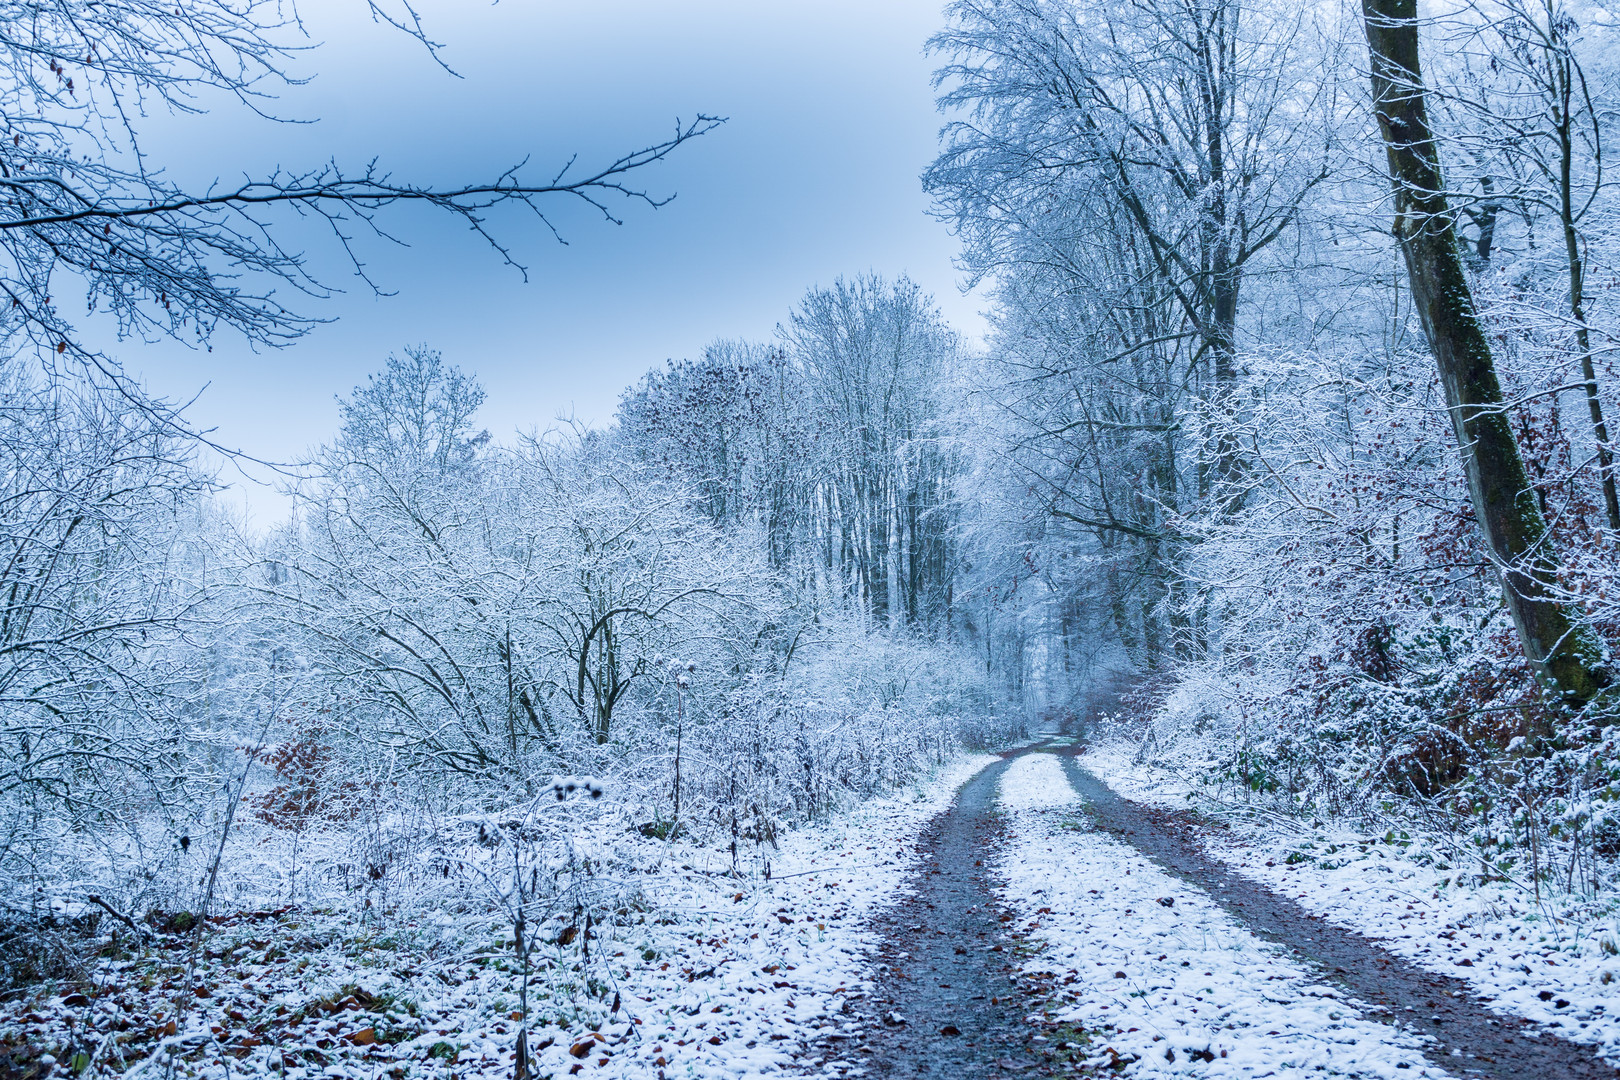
[{"xmin": 554, "ymin": 620, "xmax": 1022, "ymax": 853}]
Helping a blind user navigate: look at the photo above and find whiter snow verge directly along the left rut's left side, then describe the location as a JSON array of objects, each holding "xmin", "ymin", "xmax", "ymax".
[{"xmin": 505, "ymin": 755, "xmax": 996, "ymax": 1080}]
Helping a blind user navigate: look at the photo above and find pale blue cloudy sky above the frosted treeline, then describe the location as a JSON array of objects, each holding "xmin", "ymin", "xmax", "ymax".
[{"xmin": 104, "ymin": 0, "xmax": 982, "ymax": 523}]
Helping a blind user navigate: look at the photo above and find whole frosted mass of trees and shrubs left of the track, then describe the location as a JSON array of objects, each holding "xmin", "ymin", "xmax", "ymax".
[{"xmin": 0, "ymin": 277, "xmax": 1022, "ymax": 945}]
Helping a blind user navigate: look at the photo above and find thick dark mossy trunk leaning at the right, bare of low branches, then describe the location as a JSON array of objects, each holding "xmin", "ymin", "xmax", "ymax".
[{"xmin": 1361, "ymin": 0, "xmax": 1609, "ymax": 706}]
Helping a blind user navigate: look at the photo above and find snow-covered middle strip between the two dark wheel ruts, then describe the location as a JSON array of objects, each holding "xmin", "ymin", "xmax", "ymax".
[{"xmin": 998, "ymin": 755, "xmax": 1439, "ymax": 1078}]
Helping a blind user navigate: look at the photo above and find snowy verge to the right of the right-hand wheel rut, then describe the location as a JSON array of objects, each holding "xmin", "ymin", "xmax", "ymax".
[{"xmin": 1082, "ymin": 743, "xmax": 1620, "ymax": 1061}]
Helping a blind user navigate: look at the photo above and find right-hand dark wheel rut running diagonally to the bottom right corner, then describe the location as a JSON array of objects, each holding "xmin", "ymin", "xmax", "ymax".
[{"xmin": 1048, "ymin": 746, "xmax": 1620, "ymax": 1080}]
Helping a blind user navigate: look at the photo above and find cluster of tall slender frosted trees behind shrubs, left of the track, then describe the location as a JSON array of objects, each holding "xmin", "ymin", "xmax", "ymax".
[{"xmin": 619, "ymin": 277, "xmax": 962, "ymax": 631}]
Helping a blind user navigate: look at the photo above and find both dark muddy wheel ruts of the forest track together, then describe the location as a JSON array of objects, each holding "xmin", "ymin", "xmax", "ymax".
[{"xmin": 862, "ymin": 746, "xmax": 1620, "ymax": 1080}]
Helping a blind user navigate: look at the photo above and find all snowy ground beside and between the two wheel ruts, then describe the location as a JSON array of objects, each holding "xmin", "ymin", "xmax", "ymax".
[{"xmin": 15, "ymin": 753, "xmax": 1620, "ymax": 1080}]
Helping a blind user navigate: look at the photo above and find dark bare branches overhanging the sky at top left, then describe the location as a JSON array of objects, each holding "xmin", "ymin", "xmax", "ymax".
[{"xmin": 0, "ymin": 0, "xmax": 721, "ymax": 366}]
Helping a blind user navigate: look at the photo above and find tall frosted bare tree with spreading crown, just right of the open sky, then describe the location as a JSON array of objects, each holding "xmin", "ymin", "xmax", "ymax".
[{"xmin": 923, "ymin": 0, "xmax": 1330, "ymax": 500}]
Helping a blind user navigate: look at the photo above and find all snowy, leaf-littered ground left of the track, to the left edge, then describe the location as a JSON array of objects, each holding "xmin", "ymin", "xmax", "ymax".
[{"xmin": 0, "ymin": 755, "xmax": 993, "ymax": 1080}]
